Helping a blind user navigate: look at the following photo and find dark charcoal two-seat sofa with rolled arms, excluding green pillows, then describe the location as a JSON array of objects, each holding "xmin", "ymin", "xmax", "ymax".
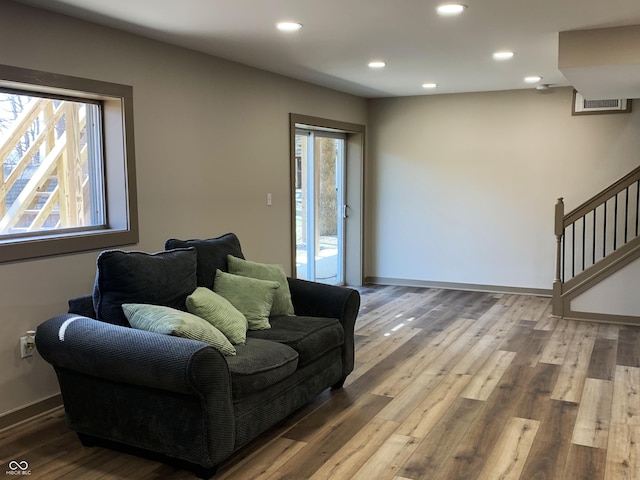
[{"xmin": 36, "ymin": 234, "xmax": 360, "ymax": 478}]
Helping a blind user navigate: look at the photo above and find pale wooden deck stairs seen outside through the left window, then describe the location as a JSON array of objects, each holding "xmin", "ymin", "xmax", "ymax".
[{"xmin": 0, "ymin": 97, "xmax": 91, "ymax": 238}]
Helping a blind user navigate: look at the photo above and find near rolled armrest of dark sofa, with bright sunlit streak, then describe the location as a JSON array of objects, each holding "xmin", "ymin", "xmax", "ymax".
[{"xmin": 36, "ymin": 314, "xmax": 235, "ymax": 469}]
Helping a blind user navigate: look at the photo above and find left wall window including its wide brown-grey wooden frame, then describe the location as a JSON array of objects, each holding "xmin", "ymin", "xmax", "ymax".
[{"xmin": 0, "ymin": 66, "xmax": 138, "ymax": 261}]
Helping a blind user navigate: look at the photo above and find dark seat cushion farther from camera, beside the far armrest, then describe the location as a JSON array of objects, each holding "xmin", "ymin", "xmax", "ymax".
[{"xmin": 247, "ymin": 315, "xmax": 344, "ymax": 367}]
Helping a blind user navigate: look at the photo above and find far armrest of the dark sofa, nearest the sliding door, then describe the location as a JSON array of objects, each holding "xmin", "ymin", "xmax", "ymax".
[{"xmin": 287, "ymin": 278, "xmax": 360, "ymax": 382}]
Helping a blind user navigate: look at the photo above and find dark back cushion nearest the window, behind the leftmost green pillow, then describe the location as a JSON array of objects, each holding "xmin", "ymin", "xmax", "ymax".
[{"xmin": 93, "ymin": 248, "xmax": 197, "ymax": 326}]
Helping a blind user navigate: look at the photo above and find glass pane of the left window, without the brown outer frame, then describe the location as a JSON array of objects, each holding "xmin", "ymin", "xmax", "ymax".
[{"xmin": 0, "ymin": 90, "xmax": 106, "ymax": 234}]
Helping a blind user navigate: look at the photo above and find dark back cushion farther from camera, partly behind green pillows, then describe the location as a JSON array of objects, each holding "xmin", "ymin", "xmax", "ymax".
[{"xmin": 164, "ymin": 233, "xmax": 244, "ymax": 290}]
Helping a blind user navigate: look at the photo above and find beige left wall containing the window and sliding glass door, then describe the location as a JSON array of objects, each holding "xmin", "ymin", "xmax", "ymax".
[{"xmin": 0, "ymin": 2, "xmax": 366, "ymax": 415}]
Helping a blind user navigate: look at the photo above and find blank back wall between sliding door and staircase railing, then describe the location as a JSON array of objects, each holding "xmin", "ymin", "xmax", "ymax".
[{"xmin": 366, "ymin": 88, "xmax": 640, "ymax": 289}]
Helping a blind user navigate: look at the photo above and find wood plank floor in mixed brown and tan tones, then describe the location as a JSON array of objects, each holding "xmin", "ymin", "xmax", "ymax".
[{"xmin": 0, "ymin": 287, "xmax": 640, "ymax": 480}]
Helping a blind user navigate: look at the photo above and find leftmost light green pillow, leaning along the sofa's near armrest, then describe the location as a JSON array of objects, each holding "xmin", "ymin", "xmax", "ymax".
[{"xmin": 122, "ymin": 303, "xmax": 236, "ymax": 355}]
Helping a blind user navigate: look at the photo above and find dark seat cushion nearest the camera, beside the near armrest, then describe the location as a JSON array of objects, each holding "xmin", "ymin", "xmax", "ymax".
[{"xmin": 227, "ymin": 338, "xmax": 298, "ymax": 398}]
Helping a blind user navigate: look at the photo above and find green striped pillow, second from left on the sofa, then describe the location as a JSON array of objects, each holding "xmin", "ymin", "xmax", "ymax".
[{"xmin": 187, "ymin": 287, "xmax": 247, "ymax": 345}]
